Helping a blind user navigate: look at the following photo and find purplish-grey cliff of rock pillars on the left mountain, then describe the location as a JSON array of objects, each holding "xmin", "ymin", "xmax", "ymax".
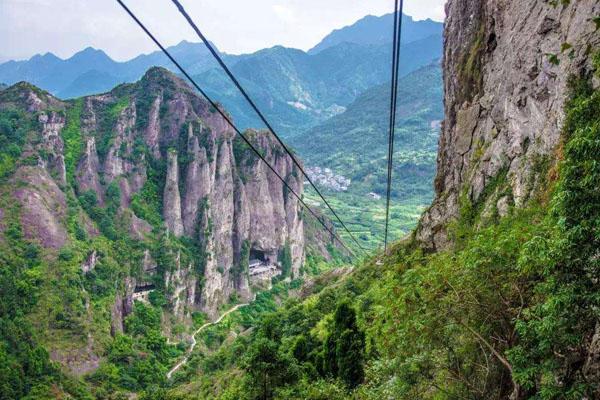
[{"xmin": 0, "ymin": 68, "xmax": 305, "ymax": 332}]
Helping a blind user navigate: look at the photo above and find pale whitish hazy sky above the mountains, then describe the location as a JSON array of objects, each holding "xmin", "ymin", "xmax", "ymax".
[{"xmin": 0, "ymin": 0, "xmax": 445, "ymax": 61}]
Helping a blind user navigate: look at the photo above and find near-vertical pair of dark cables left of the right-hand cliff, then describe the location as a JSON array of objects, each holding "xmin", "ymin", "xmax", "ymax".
[{"xmin": 384, "ymin": 0, "xmax": 404, "ymax": 252}]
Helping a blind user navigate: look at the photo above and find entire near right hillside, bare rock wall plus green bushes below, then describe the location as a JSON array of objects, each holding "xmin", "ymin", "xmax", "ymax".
[{"xmin": 152, "ymin": 0, "xmax": 600, "ymax": 400}]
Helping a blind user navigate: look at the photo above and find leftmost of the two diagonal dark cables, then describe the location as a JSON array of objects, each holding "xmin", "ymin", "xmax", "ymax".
[{"xmin": 117, "ymin": 0, "xmax": 356, "ymax": 256}]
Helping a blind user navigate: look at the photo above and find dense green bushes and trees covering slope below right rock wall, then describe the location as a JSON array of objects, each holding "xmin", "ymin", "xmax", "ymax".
[{"xmin": 148, "ymin": 60, "xmax": 600, "ymax": 400}]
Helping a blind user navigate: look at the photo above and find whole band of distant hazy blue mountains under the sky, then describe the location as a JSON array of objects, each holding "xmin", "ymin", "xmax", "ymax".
[{"xmin": 0, "ymin": 14, "xmax": 442, "ymax": 135}]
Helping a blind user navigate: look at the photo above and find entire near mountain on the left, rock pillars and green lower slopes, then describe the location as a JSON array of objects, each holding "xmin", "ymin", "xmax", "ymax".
[{"xmin": 0, "ymin": 67, "xmax": 341, "ymax": 398}]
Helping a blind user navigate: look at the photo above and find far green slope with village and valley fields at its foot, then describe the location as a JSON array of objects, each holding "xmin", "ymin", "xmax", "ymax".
[{"xmin": 290, "ymin": 64, "xmax": 443, "ymax": 248}]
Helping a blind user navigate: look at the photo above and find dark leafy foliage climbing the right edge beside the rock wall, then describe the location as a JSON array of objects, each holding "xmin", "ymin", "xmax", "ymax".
[{"xmin": 509, "ymin": 63, "xmax": 600, "ymax": 399}]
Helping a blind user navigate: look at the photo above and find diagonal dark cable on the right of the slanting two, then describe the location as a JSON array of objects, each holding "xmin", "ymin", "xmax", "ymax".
[{"xmin": 171, "ymin": 0, "xmax": 366, "ymax": 252}]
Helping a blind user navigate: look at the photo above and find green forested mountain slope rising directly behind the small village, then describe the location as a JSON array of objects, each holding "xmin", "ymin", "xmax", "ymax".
[{"xmin": 290, "ymin": 64, "xmax": 443, "ymax": 199}]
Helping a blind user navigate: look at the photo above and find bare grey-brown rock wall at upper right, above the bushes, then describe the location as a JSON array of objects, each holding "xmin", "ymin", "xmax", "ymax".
[{"xmin": 416, "ymin": 0, "xmax": 600, "ymax": 250}]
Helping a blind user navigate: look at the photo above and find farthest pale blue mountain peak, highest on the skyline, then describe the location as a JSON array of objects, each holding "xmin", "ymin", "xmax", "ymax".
[{"xmin": 308, "ymin": 14, "xmax": 444, "ymax": 54}]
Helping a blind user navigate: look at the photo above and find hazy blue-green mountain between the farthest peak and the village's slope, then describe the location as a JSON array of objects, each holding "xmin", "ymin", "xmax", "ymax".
[{"xmin": 195, "ymin": 36, "xmax": 442, "ymax": 136}]
